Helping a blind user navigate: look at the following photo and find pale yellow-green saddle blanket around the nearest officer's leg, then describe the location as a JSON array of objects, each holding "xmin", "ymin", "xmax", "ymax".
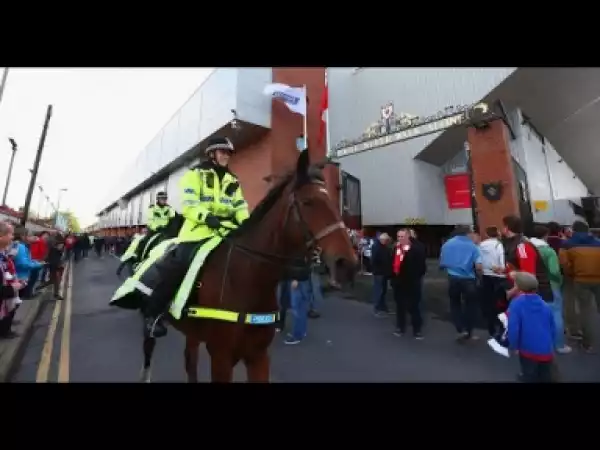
[{"xmin": 110, "ymin": 236, "xmax": 223, "ymax": 319}]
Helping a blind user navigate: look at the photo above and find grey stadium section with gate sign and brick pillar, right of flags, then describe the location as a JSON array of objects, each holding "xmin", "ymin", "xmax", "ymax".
[{"xmin": 329, "ymin": 67, "xmax": 600, "ymax": 241}]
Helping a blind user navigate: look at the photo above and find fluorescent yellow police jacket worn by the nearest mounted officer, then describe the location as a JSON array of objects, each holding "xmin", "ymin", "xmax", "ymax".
[{"xmin": 179, "ymin": 162, "xmax": 250, "ymax": 242}]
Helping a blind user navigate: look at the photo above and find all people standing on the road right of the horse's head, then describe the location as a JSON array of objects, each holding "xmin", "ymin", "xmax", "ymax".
[{"xmin": 326, "ymin": 216, "xmax": 600, "ymax": 382}]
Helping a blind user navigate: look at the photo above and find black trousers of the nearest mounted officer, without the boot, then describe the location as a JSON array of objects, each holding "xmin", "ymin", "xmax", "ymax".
[{"xmin": 140, "ymin": 242, "xmax": 198, "ymax": 318}]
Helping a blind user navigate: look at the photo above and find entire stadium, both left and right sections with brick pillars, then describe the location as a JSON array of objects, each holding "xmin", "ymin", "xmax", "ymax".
[{"xmin": 98, "ymin": 67, "xmax": 600, "ymax": 248}]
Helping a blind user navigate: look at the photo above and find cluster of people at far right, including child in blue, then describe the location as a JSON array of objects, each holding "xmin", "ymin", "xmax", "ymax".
[{"xmin": 440, "ymin": 216, "xmax": 600, "ymax": 382}]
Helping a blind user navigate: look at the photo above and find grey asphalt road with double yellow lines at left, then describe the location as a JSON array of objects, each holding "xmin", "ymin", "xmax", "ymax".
[{"xmin": 13, "ymin": 255, "xmax": 600, "ymax": 382}]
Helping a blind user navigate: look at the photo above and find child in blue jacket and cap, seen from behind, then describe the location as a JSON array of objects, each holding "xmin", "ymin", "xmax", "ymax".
[{"xmin": 507, "ymin": 272, "xmax": 556, "ymax": 383}]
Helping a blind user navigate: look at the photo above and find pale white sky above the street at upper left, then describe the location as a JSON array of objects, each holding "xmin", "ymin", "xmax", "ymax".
[{"xmin": 0, "ymin": 67, "xmax": 212, "ymax": 227}]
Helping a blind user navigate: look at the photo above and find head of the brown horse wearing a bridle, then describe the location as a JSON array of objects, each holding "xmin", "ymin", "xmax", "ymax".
[{"xmin": 286, "ymin": 150, "xmax": 358, "ymax": 275}]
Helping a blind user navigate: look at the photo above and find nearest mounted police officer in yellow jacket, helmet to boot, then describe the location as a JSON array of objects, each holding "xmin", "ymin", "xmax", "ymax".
[{"xmin": 140, "ymin": 138, "xmax": 249, "ymax": 337}]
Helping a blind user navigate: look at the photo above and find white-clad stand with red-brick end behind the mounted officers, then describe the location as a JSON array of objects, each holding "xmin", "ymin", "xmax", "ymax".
[{"xmin": 95, "ymin": 68, "xmax": 339, "ymax": 234}]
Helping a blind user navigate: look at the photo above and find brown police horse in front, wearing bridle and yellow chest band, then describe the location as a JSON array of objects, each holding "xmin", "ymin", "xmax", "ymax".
[{"xmin": 142, "ymin": 151, "xmax": 358, "ymax": 383}]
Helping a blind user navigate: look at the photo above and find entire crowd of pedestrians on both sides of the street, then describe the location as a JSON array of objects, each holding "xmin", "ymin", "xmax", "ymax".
[{"xmin": 0, "ymin": 210, "xmax": 600, "ymax": 382}]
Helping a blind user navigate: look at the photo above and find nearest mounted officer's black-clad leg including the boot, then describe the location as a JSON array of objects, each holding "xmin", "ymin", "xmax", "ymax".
[{"xmin": 140, "ymin": 243, "xmax": 195, "ymax": 338}]
